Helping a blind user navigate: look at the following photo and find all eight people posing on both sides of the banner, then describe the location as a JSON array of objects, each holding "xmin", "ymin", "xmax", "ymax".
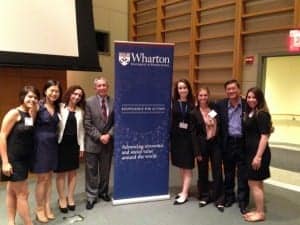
[{"xmin": 0, "ymin": 77, "xmax": 272, "ymax": 225}]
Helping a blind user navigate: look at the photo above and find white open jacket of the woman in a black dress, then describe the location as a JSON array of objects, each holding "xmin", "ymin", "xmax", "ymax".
[{"xmin": 58, "ymin": 103, "xmax": 84, "ymax": 151}]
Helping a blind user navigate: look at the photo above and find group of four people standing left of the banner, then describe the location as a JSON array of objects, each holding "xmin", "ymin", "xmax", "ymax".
[{"xmin": 0, "ymin": 77, "xmax": 113, "ymax": 225}]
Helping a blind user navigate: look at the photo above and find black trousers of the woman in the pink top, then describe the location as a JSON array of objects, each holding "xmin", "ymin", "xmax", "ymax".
[{"xmin": 198, "ymin": 139, "xmax": 223, "ymax": 205}]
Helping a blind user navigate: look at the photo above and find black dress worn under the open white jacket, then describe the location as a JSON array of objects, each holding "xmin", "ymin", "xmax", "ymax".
[{"xmin": 55, "ymin": 111, "xmax": 79, "ymax": 172}]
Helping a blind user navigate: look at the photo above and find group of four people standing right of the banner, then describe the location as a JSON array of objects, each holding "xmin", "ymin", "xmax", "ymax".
[{"xmin": 171, "ymin": 79, "xmax": 273, "ymax": 222}]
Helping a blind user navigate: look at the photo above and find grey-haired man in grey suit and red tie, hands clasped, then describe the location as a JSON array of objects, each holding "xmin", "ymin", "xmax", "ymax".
[{"xmin": 84, "ymin": 77, "xmax": 113, "ymax": 209}]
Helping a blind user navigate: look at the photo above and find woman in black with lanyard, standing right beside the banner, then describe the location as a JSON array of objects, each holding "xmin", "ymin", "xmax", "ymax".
[{"xmin": 171, "ymin": 79, "xmax": 195, "ymax": 205}]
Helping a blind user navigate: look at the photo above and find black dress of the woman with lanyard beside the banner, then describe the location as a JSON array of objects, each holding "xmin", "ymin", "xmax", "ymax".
[{"xmin": 171, "ymin": 101, "xmax": 195, "ymax": 169}]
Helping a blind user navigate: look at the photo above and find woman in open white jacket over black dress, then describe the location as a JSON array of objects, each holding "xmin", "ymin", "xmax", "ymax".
[{"xmin": 55, "ymin": 85, "xmax": 85, "ymax": 213}]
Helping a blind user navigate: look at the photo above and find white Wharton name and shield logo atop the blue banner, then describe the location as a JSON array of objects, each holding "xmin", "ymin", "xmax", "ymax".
[{"xmin": 119, "ymin": 52, "xmax": 170, "ymax": 67}]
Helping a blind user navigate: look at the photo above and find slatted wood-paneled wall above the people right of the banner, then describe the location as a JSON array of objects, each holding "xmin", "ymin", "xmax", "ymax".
[{"xmin": 129, "ymin": 0, "xmax": 300, "ymax": 98}]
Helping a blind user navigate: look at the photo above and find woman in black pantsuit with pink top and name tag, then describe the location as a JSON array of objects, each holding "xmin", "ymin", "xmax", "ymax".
[{"xmin": 193, "ymin": 87, "xmax": 224, "ymax": 212}]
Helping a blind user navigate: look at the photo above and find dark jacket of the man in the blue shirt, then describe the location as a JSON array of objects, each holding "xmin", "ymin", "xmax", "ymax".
[{"xmin": 216, "ymin": 98, "xmax": 246, "ymax": 152}]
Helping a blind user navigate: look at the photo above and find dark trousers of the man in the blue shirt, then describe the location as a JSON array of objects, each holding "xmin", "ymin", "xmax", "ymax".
[{"xmin": 223, "ymin": 137, "xmax": 249, "ymax": 207}]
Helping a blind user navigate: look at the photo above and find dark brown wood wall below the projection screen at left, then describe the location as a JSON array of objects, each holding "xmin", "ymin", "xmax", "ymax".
[{"xmin": 0, "ymin": 68, "xmax": 66, "ymax": 121}]
